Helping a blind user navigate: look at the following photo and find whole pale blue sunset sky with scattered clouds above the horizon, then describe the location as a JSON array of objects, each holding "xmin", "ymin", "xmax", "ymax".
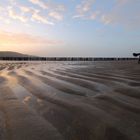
[{"xmin": 0, "ymin": 0, "xmax": 140, "ymax": 57}]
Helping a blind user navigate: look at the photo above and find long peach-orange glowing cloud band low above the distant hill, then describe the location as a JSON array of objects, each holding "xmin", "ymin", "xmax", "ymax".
[{"xmin": 0, "ymin": 31, "xmax": 63, "ymax": 47}]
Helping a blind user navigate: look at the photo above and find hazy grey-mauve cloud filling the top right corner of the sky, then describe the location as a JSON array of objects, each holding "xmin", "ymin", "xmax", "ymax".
[{"xmin": 101, "ymin": 0, "xmax": 140, "ymax": 28}]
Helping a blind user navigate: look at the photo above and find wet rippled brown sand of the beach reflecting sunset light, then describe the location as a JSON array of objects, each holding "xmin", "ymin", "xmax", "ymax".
[{"xmin": 0, "ymin": 61, "xmax": 140, "ymax": 140}]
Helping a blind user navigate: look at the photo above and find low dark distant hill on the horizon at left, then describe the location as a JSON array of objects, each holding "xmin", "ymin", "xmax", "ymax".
[{"xmin": 0, "ymin": 51, "xmax": 34, "ymax": 57}]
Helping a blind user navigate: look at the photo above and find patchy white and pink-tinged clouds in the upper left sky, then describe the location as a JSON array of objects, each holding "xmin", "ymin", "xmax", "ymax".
[{"xmin": 0, "ymin": 0, "xmax": 66, "ymax": 25}]
